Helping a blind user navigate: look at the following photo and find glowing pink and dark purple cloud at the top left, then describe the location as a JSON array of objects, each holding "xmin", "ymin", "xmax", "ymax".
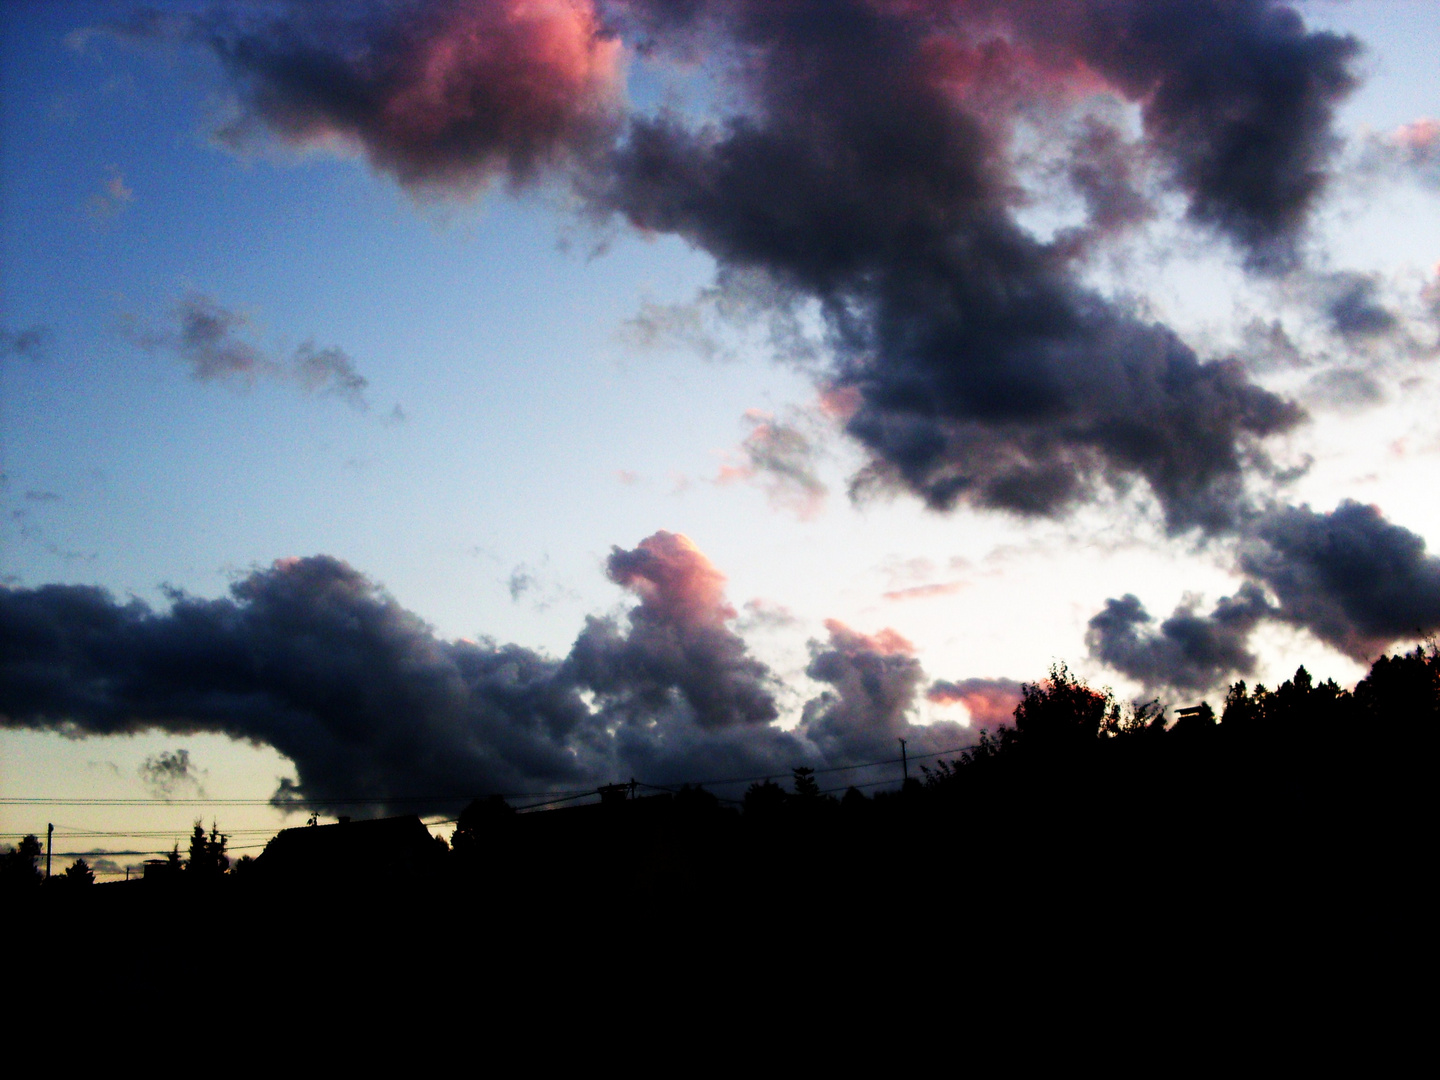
[{"xmin": 167, "ymin": 0, "xmax": 621, "ymax": 193}]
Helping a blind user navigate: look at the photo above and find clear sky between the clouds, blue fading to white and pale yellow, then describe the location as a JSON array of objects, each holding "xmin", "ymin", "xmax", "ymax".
[{"xmin": 0, "ymin": 0, "xmax": 1440, "ymax": 875}]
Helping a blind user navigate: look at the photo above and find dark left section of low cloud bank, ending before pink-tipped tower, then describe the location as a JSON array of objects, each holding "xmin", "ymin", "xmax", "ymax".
[{"xmin": 0, "ymin": 556, "xmax": 598, "ymax": 806}]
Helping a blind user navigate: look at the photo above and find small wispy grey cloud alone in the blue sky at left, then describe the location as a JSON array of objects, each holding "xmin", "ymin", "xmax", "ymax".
[{"xmin": 127, "ymin": 292, "xmax": 371, "ymax": 408}]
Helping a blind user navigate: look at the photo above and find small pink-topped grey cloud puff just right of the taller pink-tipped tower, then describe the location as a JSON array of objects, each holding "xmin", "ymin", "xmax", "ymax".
[{"xmin": 801, "ymin": 619, "xmax": 972, "ymax": 765}]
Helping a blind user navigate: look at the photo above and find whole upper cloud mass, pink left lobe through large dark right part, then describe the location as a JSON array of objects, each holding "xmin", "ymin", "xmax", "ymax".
[{"xmin": 106, "ymin": 0, "xmax": 1353, "ymax": 531}]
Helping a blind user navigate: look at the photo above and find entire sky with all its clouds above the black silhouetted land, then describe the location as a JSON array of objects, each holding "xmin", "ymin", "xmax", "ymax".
[{"xmin": 0, "ymin": 0, "xmax": 1440, "ymax": 874}]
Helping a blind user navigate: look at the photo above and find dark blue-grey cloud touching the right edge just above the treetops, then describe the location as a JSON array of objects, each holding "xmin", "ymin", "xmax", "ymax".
[{"xmin": 1240, "ymin": 501, "xmax": 1440, "ymax": 660}]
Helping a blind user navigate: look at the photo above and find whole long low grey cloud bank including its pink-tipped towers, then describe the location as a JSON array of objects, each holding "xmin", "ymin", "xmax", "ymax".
[{"xmin": 0, "ymin": 533, "xmax": 971, "ymax": 809}]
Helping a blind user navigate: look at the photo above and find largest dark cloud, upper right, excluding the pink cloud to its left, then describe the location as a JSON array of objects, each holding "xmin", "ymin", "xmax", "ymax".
[{"xmin": 596, "ymin": 1, "xmax": 1319, "ymax": 530}]
